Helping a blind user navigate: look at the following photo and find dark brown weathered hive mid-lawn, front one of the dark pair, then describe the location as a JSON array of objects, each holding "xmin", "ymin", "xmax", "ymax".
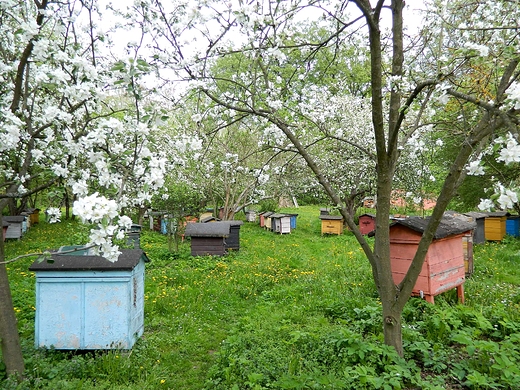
[{"xmin": 184, "ymin": 222, "xmax": 230, "ymax": 256}]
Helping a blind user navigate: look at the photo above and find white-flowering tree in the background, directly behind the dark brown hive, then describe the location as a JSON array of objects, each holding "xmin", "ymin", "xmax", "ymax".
[{"xmin": 161, "ymin": 87, "xmax": 293, "ymax": 220}]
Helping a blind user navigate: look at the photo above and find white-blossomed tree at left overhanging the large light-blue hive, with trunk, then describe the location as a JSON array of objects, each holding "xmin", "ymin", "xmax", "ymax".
[{"xmin": 0, "ymin": 0, "xmax": 165, "ymax": 376}]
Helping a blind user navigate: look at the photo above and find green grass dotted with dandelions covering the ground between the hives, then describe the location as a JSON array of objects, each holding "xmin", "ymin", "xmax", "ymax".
[{"xmin": 0, "ymin": 207, "xmax": 520, "ymax": 390}]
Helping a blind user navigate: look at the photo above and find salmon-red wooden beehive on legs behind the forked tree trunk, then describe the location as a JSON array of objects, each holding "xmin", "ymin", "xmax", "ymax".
[{"xmin": 390, "ymin": 217, "xmax": 473, "ymax": 303}]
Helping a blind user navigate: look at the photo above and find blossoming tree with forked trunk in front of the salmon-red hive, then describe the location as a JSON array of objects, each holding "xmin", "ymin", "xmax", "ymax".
[{"xmin": 135, "ymin": 0, "xmax": 519, "ymax": 354}]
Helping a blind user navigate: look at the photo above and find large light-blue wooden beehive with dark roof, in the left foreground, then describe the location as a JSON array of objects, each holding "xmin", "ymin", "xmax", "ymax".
[{"xmin": 29, "ymin": 247, "xmax": 149, "ymax": 350}]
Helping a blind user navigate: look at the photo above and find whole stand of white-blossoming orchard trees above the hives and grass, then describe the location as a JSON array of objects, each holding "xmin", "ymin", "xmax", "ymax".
[{"xmin": 0, "ymin": 0, "xmax": 520, "ymax": 384}]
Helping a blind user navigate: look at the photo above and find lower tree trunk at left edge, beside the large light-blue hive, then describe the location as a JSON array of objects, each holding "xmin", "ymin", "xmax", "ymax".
[{"xmin": 0, "ymin": 215, "xmax": 25, "ymax": 379}]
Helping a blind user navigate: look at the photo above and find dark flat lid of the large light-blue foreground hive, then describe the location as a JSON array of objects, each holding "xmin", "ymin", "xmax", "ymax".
[{"xmin": 29, "ymin": 249, "xmax": 150, "ymax": 271}]
